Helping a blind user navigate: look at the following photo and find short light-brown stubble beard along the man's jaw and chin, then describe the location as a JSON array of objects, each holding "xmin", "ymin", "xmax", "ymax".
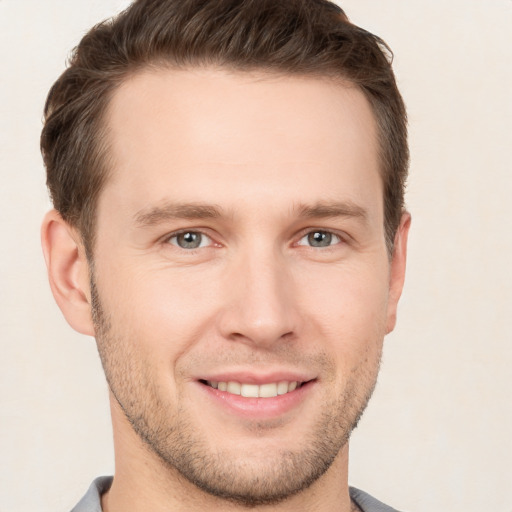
[{"xmin": 91, "ymin": 278, "xmax": 380, "ymax": 508}]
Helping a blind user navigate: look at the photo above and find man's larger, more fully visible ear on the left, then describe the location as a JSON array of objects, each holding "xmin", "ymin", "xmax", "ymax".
[{"xmin": 41, "ymin": 210, "xmax": 94, "ymax": 336}]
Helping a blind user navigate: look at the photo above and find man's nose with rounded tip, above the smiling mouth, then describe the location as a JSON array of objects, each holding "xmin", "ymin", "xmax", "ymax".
[{"xmin": 219, "ymin": 245, "xmax": 300, "ymax": 347}]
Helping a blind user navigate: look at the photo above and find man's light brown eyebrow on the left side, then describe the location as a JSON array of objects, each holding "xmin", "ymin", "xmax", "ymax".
[{"xmin": 134, "ymin": 203, "xmax": 222, "ymax": 227}]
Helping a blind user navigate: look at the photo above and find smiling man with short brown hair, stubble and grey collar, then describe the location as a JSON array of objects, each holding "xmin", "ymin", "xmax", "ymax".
[{"xmin": 42, "ymin": 0, "xmax": 410, "ymax": 512}]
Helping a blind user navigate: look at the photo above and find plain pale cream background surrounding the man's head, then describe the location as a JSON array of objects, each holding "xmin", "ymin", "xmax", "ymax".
[{"xmin": 0, "ymin": 0, "xmax": 512, "ymax": 512}]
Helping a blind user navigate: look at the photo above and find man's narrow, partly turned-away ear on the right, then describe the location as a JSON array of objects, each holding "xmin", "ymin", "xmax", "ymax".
[{"xmin": 386, "ymin": 212, "xmax": 411, "ymax": 334}]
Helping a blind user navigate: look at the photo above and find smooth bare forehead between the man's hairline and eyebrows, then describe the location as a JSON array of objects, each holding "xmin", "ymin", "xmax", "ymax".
[{"xmin": 100, "ymin": 68, "xmax": 382, "ymax": 220}]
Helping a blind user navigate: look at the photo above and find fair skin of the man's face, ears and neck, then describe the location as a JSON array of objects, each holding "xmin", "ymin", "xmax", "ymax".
[{"xmin": 43, "ymin": 69, "xmax": 410, "ymax": 512}]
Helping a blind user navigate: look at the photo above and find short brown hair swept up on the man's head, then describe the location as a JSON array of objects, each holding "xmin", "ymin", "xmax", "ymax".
[{"xmin": 41, "ymin": 0, "xmax": 409, "ymax": 257}]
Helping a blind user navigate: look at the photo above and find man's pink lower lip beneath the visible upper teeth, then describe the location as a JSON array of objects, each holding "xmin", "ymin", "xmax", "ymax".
[{"xmin": 197, "ymin": 381, "xmax": 315, "ymax": 420}]
